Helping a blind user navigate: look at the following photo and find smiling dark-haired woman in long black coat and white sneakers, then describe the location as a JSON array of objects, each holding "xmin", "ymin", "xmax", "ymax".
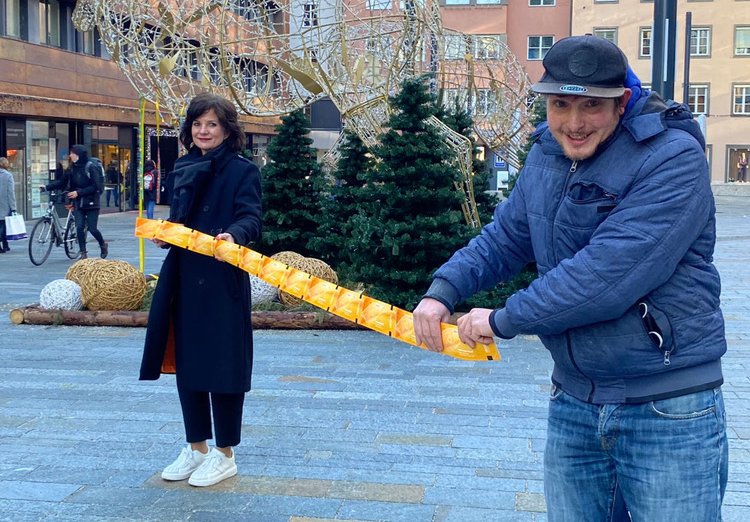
[{"xmin": 140, "ymin": 93, "xmax": 261, "ymax": 486}]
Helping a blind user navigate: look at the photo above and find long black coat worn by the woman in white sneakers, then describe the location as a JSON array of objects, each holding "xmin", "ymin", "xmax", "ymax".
[{"xmin": 140, "ymin": 146, "xmax": 261, "ymax": 393}]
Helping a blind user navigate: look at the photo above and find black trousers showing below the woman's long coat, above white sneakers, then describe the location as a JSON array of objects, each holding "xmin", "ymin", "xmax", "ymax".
[{"xmin": 177, "ymin": 386, "xmax": 245, "ymax": 448}]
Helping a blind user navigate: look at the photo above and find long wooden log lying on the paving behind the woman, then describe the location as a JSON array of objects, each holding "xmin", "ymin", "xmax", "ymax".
[{"xmin": 10, "ymin": 305, "xmax": 362, "ymax": 330}]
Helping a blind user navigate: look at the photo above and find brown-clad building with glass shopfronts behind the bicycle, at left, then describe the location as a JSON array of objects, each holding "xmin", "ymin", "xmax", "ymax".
[{"xmin": 0, "ymin": 0, "xmax": 278, "ymax": 219}]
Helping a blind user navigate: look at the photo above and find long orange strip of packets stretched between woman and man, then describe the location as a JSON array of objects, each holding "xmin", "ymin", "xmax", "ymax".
[{"xmin": 135, "ymin": 218, "xmax": 500, "ymax": 361}]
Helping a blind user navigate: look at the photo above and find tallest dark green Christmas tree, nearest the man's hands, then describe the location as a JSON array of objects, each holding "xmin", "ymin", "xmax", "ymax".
[{"xmin": 347, "ymin": 78, "xmax": 469, "ymax": 309}]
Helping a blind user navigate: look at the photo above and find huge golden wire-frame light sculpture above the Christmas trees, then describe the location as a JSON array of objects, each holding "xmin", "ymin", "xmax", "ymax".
[{"xmin": 73, "ymin": 0, "xmax": 530, "ymax": 226}]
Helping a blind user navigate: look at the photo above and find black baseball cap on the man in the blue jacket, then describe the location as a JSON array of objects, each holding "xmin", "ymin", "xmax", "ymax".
[{"xmin": 531, "ymin": 35, "xmax": 628, "ymax": 98}]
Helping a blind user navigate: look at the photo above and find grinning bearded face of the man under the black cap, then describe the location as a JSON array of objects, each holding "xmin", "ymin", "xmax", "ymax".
[{"xmin": 547, "ymin": 89, "xmax": 630, "ymax": 161}]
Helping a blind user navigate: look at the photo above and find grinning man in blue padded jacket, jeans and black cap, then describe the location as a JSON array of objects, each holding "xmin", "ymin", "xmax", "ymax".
[{"xmin": 414, "ymin": 36, "xmax": 728, "ymax": 522}]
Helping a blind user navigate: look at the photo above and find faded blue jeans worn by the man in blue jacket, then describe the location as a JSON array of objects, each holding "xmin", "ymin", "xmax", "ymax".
[{"xmin": 544, "ymin": 386, "xmax": 729, "ymax": 522}]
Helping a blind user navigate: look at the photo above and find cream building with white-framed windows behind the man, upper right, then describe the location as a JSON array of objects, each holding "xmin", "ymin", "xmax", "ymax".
[{"xmin": 571, "ymin": 0, "xmax": 750, "ymax": 183}]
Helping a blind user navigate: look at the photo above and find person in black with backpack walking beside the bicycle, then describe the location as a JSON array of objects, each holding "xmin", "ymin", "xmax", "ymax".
[{"xmin": 41, "ymin": 145, "xmax": 109, "ymax": 259}]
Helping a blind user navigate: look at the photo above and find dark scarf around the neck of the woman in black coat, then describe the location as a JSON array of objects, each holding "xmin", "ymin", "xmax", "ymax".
[{"xmin": 169, "ymin": 142, "xmax": 235, "ymax": 223}]
